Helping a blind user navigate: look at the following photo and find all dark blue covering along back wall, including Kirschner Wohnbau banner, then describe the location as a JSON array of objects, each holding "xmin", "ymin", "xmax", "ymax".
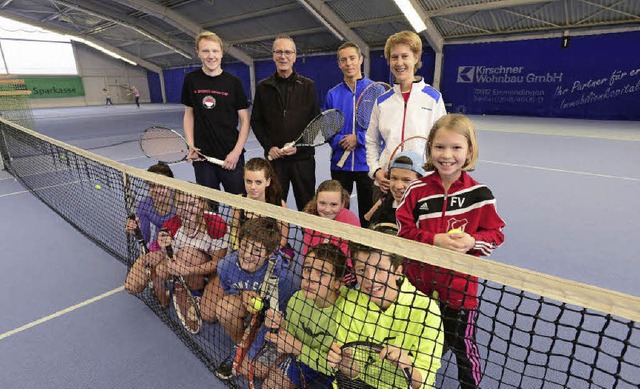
[{"xmin": 148, "ymin": 32, "xmax": 640, "ymax": 120}]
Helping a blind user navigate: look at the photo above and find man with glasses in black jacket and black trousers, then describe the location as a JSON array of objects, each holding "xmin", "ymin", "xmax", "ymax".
[{"xmin": 251, "ymin": 35, "xmax": 320, "ymax": 210}]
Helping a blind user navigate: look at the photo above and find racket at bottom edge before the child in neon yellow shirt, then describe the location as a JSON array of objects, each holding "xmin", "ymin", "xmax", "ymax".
[{"xmin": 336, "ymin": 341, "xmax": 411, "ymax": 389}]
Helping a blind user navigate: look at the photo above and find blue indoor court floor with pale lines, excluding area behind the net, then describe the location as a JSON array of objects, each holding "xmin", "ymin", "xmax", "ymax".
[{"xmin": 0, "ymin": 105, "xmax": 640, "ymax": 388}]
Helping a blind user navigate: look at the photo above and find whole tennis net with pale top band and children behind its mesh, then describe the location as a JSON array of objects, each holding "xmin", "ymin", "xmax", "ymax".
[{"xmin": 0, "ymin": 120, "xmax": 640, "ymax": 388}]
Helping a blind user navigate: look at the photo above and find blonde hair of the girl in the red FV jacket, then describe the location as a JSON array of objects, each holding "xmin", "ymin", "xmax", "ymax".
[{"xmin": 424, "ymin": 113, "xmax": 478, "ymax": 171}]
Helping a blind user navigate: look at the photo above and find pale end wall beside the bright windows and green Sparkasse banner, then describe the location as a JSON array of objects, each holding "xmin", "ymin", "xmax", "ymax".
[{"xmin": 30, "ymin": 42, "xmax": 151, "ymax": 108}]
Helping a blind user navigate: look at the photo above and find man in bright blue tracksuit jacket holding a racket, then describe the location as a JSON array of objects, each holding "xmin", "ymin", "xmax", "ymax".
[{"xmin": 323, "ymin": 42, "xmax": 373, "ymax": 226}]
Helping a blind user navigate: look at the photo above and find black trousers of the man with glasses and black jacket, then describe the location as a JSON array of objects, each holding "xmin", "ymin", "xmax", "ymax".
[{"xmin": 271, "ymin": 156, "xmax": 316, "ymax": 211}]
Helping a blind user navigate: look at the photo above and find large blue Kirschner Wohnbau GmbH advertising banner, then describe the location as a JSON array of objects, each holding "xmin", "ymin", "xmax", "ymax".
[{"xmin": 441, "ymin": 32, "xmax": 640, "ymax": 120}]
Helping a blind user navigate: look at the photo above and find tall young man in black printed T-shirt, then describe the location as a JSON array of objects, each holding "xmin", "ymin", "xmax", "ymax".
[{"xmin": 182, "ymin": 31, "xmax": 249, "ymax": 194}]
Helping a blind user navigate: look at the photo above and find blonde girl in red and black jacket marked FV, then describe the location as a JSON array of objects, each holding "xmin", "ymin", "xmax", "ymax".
[{"xmin": 396, "ymin": 114, "xmax": 505, "ymax": 389}]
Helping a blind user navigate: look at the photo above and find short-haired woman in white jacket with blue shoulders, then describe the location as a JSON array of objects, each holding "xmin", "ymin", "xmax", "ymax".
[{"xmin": 366, "ymin": 31, "xmax": 447, "ymax": 197}]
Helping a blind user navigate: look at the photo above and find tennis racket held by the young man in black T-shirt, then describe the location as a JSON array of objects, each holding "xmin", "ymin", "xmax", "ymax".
[{"xmin": 140, "ymin": 126, "xmax": 224, "ymax": 166}]
